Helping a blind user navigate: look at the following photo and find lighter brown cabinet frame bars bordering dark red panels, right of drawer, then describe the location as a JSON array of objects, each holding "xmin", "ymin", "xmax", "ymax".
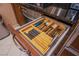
[{"xmin": 57, "ymin": 24, "xmax": 79, "ymax": 56}]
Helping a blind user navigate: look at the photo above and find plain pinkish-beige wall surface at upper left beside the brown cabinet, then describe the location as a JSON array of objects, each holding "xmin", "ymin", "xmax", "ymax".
[{"xmin": 0, "ymin": 3, "xmax": 18, "ymax": 27}]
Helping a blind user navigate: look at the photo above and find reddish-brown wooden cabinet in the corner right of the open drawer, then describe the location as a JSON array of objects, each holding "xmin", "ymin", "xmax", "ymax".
[{"xmin": 58, "ymin": 24, "xmax": 79, "ymax": 56}]
